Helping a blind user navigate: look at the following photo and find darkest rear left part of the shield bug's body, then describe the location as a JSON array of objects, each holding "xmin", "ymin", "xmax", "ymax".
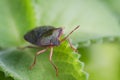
[{"xmin": 24, "ymin": 26, "xmax": 55, "ymax": 46}]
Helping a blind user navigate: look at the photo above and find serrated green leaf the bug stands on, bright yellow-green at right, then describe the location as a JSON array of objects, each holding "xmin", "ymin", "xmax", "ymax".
[{"xmin": 0, "ymin": 42, "xmax": 87, "ymax": 80}]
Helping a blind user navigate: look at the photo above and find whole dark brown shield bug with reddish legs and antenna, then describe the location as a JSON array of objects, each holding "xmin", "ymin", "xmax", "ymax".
[{"xmin": 24, "ymin": 26, "xmax": 79, "ymax": 76}]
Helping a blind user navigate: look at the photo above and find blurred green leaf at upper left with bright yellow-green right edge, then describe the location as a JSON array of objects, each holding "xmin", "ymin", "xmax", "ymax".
[{"xmin": 0, "ymin": 0, "xmax": 35, "ymax": 47}]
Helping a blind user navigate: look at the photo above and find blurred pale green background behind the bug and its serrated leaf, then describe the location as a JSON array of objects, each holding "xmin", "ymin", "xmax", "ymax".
[{"xmin": 0, "ymin": 0, "xmax": 120, "ymax": 80}]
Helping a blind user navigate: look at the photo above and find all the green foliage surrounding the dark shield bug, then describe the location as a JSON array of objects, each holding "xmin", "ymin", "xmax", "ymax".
[{"xmin": 0, "ymin": 0, "xmax": 120, "ymax": 80}]
